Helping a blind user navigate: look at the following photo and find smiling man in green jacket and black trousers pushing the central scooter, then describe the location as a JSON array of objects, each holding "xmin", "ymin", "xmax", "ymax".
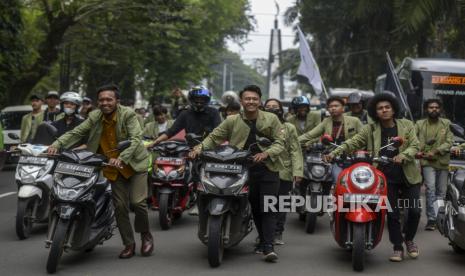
[{"xmin": 189, "ymin": 85, "xmax": 285, "ymax": 262}]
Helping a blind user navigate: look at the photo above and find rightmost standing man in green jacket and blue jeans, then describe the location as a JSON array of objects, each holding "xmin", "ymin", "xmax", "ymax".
[{"xmin": 415, "ymin": 99, "xmax": 453, "ymax": 231}]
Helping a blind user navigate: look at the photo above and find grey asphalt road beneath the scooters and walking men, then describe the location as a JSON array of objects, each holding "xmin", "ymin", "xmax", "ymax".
[{"xmin": 0, "ymin": 171, "xmax": 465, "ymax": 276}]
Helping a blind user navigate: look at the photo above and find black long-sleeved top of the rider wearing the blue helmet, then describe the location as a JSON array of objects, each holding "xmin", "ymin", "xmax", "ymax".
[{"xmin": 166, "ymin": 106, "xmax": 221, "ymax": 137}]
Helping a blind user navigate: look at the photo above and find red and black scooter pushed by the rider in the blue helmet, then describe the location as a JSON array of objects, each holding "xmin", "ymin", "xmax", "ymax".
[{"xmin": 151, "ymin": 140, "xmax": 195, "ymax": 230}]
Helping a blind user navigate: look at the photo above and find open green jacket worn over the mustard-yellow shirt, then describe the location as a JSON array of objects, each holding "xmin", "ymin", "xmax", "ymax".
[{"xmin": 52, "ymin": 105, "xmax": 149, "ymax": 172}]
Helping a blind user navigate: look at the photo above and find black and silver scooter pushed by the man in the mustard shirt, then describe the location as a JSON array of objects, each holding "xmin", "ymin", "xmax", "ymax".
[{"xmin": 46, "ymin": 141, "xmax": 130, "ymax": 273}]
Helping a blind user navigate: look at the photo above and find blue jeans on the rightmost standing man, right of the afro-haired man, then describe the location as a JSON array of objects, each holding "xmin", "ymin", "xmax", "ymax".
[{"xmin": 423, "ymin": 166, "xmax": 449, "ymax": 221}]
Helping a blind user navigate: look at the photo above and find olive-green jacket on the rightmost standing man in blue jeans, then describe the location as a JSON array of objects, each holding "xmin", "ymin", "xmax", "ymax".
[{"xmin": 415, "ymin": 118, "xmax": 454, "ymax": 170}]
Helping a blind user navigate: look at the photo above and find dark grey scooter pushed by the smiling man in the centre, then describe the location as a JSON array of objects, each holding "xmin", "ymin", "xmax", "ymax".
[{"xmin": 191, "ymin": 138, "xmax": 271, "ymax": 267}]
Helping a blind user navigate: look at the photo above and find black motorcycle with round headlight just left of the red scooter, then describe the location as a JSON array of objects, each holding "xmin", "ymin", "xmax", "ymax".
[{"xmin": 299, "ymin": 143, "xmax": 332, "ymax": 234}]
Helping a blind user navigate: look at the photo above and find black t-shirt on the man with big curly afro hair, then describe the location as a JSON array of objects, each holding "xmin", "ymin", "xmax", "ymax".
[{"xmin": 379, "ymin": 125, "xmax": 404, "ymax": 183}]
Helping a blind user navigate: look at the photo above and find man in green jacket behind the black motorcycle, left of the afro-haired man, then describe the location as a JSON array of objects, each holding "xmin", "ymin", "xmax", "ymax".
[{"xmin": 299, "ymin": 96, "xmax": 362, "ymax": 182}]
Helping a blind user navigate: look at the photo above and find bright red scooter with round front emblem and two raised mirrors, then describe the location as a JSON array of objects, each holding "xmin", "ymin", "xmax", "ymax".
[{"xmin": 321, "ymin": 135, "xmax": 402, "ymax": 271}]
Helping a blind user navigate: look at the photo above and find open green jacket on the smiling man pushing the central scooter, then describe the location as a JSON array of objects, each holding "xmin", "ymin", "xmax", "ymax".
[{"xmin": 197, "ymin": 110, "xmax": 286, "ymax": 172}]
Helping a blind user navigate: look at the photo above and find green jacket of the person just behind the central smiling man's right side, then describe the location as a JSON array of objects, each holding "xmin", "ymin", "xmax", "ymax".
[{"xmin": 279, "ymin": 123, "xmax": 304, "ymax": 181}]
